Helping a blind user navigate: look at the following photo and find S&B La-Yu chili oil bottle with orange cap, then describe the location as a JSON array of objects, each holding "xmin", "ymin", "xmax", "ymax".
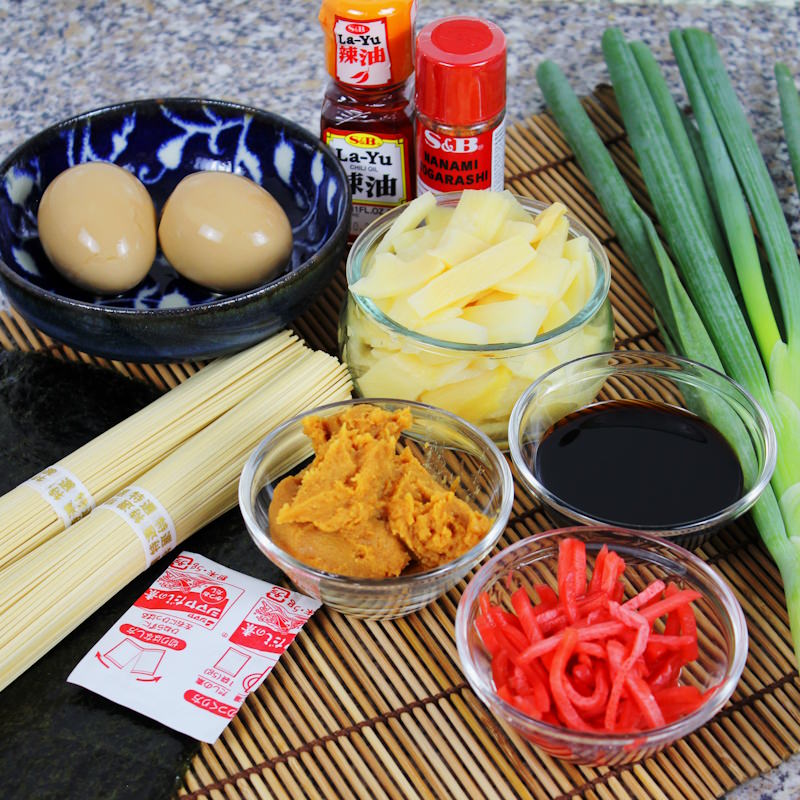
[{"xmin": 319, "ymin": 0, "xmax": 416, "ymax": 236}]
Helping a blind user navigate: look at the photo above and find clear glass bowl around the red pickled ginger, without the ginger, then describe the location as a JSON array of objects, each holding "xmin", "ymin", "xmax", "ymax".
[{"xmin": 456, "ymin": 527, "xmax": 748, "ymax": 766}]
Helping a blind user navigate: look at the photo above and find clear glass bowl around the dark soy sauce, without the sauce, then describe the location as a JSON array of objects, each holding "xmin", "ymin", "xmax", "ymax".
[{"xmin": 508, "ymin": 351, "xmax": 777, "ymax": 549}]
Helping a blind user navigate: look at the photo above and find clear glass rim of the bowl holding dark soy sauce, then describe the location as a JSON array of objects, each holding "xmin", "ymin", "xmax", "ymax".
[{"xmin": 508, "ymin": 350, "xmax": 778, "ymax": 539}]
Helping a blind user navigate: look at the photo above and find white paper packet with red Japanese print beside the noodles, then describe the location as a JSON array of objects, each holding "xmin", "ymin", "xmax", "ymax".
[{"xmin": 68, "ymin": 552, "xmax": 319, "ymax": 742}]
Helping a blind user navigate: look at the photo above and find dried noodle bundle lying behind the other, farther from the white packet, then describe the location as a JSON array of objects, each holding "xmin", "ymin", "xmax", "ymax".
[{"xmin": 0, "ymin": 331, "xmax": 303, "ymax": 568}]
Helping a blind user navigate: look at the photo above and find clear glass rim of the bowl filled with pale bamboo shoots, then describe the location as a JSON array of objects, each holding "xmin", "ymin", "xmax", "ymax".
[{"xmin": 345, "ymin": 190, "xmax": 611, "ymax": 355}]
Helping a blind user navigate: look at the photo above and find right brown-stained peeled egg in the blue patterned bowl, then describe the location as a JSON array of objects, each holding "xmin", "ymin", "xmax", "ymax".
[{"xmin": 158, "ymin": 172, "xmax": 292, "ymax": 292}]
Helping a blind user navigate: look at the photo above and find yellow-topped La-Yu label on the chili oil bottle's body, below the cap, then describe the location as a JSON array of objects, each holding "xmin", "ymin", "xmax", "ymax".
[{"xmin": 323, "ymin": 128, "xmax": 411, "ymax": 234}]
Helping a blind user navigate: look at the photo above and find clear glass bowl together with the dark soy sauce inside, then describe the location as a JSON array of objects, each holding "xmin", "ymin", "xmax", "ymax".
[{"xmin": 508, "ymin": 350, "xmax": 776, "ymax": 549}]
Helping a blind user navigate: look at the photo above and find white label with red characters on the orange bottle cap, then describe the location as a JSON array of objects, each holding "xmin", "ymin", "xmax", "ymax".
[{"xmin": 333, "ymin": 16, "xmax": 392, "ymax": 86}]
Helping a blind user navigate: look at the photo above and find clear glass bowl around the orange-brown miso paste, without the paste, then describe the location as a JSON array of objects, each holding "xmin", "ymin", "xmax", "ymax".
[{"xmin": 239, "ymin": 399, "xmax": 514, "ymax": 619}]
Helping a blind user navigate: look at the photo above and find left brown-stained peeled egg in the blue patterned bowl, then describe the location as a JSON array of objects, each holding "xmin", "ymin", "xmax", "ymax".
[{"xmin": 39, "ymin": 161, "xmax": 156, "ymax": 294}]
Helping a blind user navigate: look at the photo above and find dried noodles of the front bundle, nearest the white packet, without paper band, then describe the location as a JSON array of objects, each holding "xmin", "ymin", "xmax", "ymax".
[{"xmin": 0, "ymin": 349, "xmax": 350, "ymax": 690}]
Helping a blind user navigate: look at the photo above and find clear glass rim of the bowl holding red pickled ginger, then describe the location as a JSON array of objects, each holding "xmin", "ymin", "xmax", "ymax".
[{"xmin": 455, "ymin": 525, "xmax": 749, "ymax": 747}]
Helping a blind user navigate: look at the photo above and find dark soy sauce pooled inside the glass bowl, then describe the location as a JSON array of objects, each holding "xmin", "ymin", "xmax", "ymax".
[{"xmin": 534, "ymin": 400, "xmax": 742, "ymax": 528}]
